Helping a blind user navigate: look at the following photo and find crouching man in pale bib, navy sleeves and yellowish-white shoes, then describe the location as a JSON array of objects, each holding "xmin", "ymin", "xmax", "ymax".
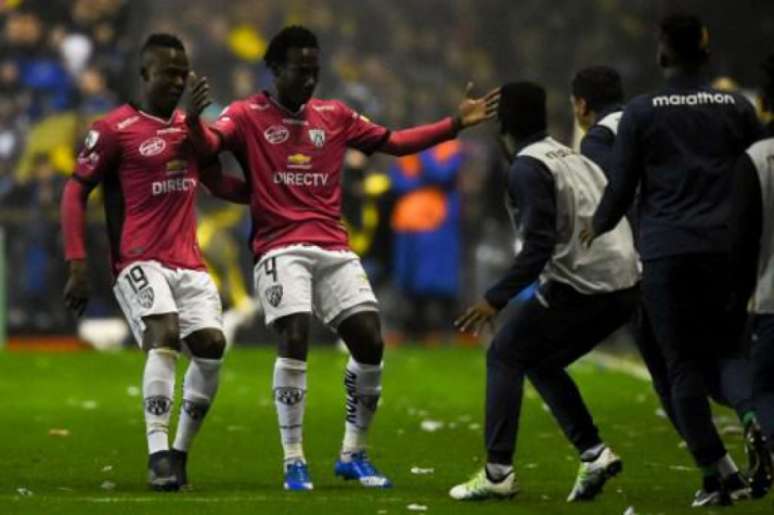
[{"xmin": 449, "ymin": 82, "xmax": 639, "ymax": 502}]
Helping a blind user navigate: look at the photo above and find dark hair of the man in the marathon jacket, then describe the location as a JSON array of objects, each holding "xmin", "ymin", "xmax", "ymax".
[{"xmin": 659, "ymin": 13, "xmax": 709, "ymax": 66}]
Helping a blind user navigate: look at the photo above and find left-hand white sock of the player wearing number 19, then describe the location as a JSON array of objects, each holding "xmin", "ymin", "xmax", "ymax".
[{"xmin": 142, "ymin": 349, "xmax": 178, "ymax": 454}]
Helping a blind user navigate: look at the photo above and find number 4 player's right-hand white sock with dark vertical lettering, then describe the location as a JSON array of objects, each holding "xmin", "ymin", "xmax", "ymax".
[{"xmin": 341, "ymin": 357, "xmax": 382, "ymax": 461}]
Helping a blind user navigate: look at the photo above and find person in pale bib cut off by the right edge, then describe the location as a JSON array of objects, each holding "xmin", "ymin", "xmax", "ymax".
[{"xmin": 732, "ymin": 54, "xmax": 774, "ymax": 496}]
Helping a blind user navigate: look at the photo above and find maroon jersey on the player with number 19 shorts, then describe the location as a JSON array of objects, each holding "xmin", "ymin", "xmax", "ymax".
[{"xmin": 72, "ymin": 105, "xmax": 205, "ymax": 274}]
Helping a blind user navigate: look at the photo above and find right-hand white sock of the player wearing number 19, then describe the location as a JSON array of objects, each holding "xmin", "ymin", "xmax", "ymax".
[{"xmin": 172, "ymin": 357, "xmax": 223, "ymax": 452}]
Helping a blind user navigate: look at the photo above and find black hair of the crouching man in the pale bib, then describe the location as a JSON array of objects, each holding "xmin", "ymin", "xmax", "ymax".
[{"xmin": 497, "ymin": 81, "xmax": 548, "ymax": 138}]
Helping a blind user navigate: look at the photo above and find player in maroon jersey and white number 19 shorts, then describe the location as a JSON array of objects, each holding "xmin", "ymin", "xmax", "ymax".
[{"xmin": 61, "ymin": 34, "xmax": 249, "ymax": 490}]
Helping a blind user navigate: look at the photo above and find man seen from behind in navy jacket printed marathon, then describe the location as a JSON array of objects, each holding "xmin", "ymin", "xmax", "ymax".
[{"xmin": 583, "ymin": 14, "xmax": 760, "ymax": 506}]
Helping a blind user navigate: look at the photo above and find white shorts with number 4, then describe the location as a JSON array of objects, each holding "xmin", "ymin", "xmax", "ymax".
[{"xmin": 253, "ymin": 245, "xmax": 379, "ymax": 329}]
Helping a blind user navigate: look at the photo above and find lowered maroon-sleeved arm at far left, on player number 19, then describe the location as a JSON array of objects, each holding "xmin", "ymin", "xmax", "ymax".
[{"xmin": 60, "ymin": 123, "xmax": 115, "ymax": 316}]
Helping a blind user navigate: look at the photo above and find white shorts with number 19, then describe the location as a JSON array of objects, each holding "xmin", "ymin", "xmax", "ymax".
[{"xmin": 113, "ymin": 261, "xmax": 223, "ymax": 347}]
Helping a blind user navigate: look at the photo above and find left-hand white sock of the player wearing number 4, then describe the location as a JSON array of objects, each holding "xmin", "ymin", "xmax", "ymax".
[{"xmin": 274, "ymin": 358, "xmax": 306, "ymax": 461}]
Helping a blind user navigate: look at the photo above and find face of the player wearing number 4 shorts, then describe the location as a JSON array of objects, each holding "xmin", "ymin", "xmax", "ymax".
[{"xmin": 276, "ymin": 48, "xmax": 320, "ymax": 108}]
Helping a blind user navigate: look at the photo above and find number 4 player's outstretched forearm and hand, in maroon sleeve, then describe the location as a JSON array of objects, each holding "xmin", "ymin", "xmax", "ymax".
[{"xmin": 377, "ymin": 83, "xmax": 500, "ymax": 156}]
